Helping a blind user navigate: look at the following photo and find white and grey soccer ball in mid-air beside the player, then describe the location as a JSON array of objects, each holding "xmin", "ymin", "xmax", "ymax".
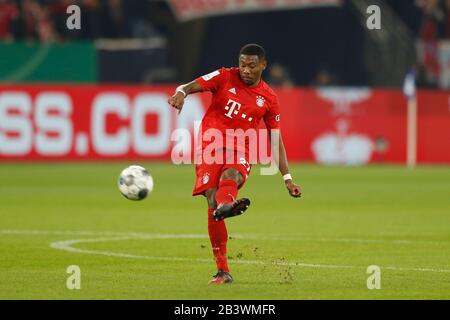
[{"xmin": 118, "ymin": 165, "xmax": 153, "ymax": 200}]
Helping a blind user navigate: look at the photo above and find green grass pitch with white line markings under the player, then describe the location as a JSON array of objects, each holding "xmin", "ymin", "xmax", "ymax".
[{"xmin": 0, "ymin": 162, "xmax": 450, "ymax": 300}]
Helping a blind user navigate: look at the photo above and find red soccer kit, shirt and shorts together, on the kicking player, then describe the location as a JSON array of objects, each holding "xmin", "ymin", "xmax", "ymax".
[{"xmin": 192, "ymin": 68, "xmax": 280, "ymax": 195}]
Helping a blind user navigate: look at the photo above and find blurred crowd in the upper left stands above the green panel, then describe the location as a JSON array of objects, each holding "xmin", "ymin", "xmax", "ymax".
[{"xmin": 0, "ymin": 0, "xmax": 159, "ymax": 42}]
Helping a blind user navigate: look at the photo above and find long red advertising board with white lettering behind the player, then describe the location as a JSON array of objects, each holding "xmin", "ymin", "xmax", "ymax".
[{"xmin": 0, "ymin": 85, "xmax": 450, "ymax": 165}]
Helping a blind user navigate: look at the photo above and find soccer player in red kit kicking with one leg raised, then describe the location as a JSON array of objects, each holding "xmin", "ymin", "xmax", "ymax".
[{"xmin": 168, "ymin": 44, "xmax": 301, "ymax": 284}]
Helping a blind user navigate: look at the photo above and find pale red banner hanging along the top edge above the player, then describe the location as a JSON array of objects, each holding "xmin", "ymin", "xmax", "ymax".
[{"xmin": 167, "ymin": 0, "xmax": 341, "ymax": 21}]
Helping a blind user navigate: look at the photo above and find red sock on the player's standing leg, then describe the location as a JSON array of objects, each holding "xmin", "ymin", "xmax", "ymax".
[{"xmin": 208, "ymin": 209, "xmax": 230, "ymax": 272}]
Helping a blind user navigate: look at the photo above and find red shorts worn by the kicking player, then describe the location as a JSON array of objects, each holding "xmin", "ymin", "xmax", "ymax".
[{"xmin": 192, "ymin": 151, "xmax": 252, "ymax": 196}]
